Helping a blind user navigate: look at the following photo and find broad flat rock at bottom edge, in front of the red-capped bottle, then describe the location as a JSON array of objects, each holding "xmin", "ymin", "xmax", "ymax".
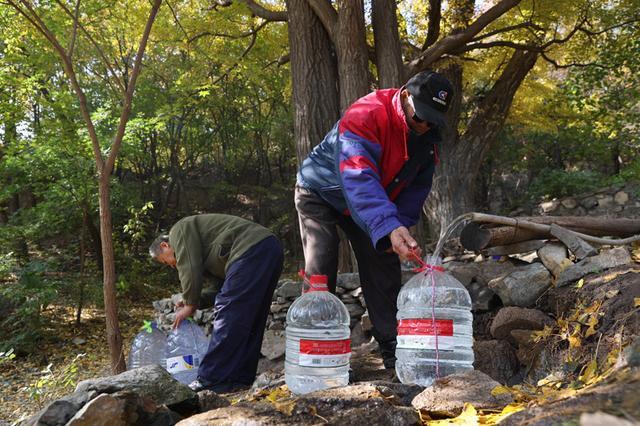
[{"xmin": 178, "ymin": 384, "xmax": 422, "ymax": 426}]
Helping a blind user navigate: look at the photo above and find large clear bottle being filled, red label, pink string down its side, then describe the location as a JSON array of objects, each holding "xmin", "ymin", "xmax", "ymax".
[{"xmin": 396, "ymin": 259, "xmax": 473, "ymax": 386}]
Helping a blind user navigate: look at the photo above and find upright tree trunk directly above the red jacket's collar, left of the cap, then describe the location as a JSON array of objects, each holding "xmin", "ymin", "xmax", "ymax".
[{"xmin": 371, "ymin": 0, "xmax": 405, "ymax": 89}]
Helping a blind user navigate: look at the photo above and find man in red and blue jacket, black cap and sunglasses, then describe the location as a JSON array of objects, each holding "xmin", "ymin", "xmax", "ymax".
[{"xmin": 295, "ymin": 71, "xmax": 453, "ymax": 368}]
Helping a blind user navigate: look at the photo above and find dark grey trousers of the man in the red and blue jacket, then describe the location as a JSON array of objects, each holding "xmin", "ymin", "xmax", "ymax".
[{"xmin": 295, "ymin": 186, "xmax": 401, "ymax": 358}]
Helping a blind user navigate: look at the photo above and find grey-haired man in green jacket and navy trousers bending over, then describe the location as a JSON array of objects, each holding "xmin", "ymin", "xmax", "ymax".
[{"xmin": 149, "ymin": 214, "xmax": 283, "ymax": 392}]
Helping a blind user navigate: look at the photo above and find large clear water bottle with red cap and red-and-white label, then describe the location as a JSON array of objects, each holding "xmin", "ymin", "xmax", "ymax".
[{"xmin": 284, "ymin": 275, "xmax": 351, "ymax": 395}]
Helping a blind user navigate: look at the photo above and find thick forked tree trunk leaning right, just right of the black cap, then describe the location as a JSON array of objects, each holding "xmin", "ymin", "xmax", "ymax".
[{"xmin": 425, "ymin": 50, "xmax": 538, "ymax": 236}]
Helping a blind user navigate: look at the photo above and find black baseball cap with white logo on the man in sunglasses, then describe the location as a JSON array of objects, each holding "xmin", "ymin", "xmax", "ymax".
[{"xmin": 405, "ymin": 70, "xmax": 453, "ymax": 128}]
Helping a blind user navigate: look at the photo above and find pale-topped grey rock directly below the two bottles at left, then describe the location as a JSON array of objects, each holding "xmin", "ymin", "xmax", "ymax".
[{"xmin": 76, "ymin": 365, "xmax": 197, "ymax": 412}]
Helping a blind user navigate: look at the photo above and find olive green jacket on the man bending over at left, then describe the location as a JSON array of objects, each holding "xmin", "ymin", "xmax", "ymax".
[{"xmin": 169, "ymin": 214, "xmax": 273, "ymax": 305}]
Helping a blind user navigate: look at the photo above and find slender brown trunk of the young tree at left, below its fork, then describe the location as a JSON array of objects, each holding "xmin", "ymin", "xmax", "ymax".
[{"xmin": 98, "ymin": 173, "xmax": 127, "ymax": 374}]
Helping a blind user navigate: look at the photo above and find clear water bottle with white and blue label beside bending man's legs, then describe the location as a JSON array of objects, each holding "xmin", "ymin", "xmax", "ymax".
[{"xmin": 167, "ymin": 320, "xmax": 209, "ymax": 385}]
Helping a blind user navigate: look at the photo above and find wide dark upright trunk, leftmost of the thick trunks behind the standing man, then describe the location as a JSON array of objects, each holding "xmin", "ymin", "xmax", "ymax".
[{"xmin": 287, "ymin": 0, "xmax": 340, "ymax": 164}]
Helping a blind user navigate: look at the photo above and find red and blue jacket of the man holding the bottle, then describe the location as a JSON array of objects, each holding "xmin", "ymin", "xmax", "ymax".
[{"xmin": 297, "ymin": 89, "xmax": 440, "ymax": 250}]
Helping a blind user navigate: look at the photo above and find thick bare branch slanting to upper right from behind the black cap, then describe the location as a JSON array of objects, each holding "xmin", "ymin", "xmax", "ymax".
[{"xmin": 408, "ymin": 0, "xmax": 521, "ymax": 74}]
